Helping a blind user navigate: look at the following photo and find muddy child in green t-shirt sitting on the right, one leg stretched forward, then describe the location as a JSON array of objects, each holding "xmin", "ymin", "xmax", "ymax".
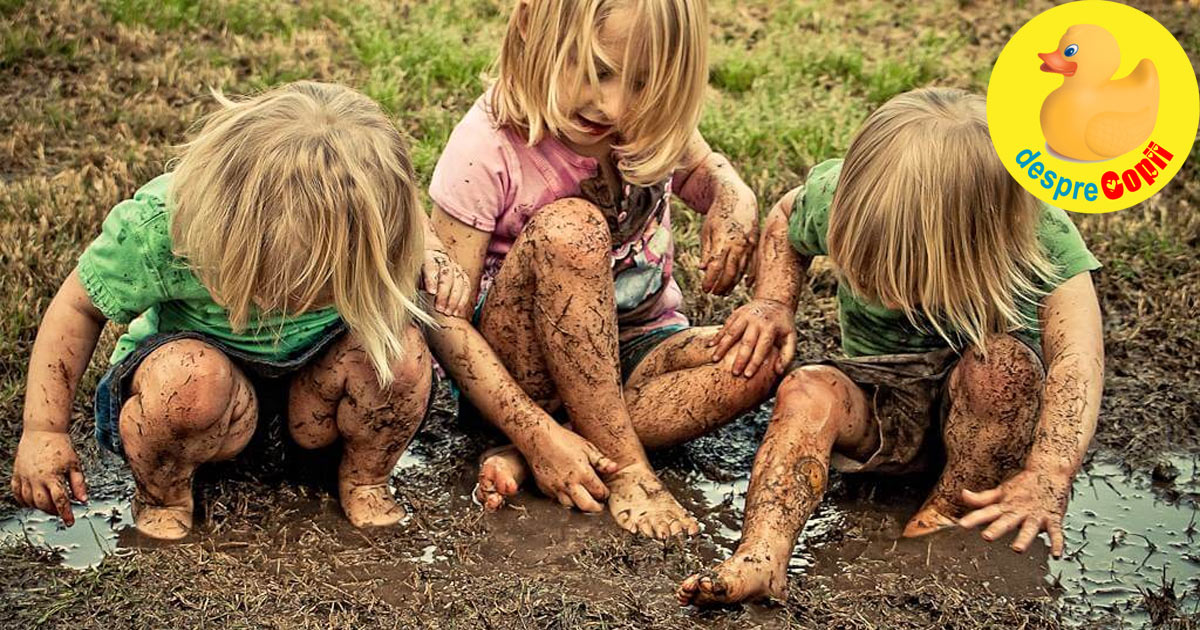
[{"xmin": 678, "ymin": 89, "xmax": 1103, "ymax": 605}]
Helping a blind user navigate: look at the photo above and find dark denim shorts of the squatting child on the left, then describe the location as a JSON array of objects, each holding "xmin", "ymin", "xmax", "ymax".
[{"xmin": 95, "ymin": 322, "xmax": 437, "ymax": 473}]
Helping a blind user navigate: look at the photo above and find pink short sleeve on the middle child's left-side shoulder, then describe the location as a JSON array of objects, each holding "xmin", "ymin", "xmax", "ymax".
[{"xmin": 430, "ymin": 103, "xmax": 512, "ymax": 232}]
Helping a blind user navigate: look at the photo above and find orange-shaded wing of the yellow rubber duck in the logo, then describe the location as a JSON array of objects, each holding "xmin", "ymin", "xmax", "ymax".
[{"xmin": 1084, "ymin": 59, "xmax": 1158, "ymax": 157}]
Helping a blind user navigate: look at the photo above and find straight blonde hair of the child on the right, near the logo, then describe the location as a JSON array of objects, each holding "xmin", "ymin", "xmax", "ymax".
[{"xmin": 828, "ymin": 89, "xmax": 1055, "ymax": 352}]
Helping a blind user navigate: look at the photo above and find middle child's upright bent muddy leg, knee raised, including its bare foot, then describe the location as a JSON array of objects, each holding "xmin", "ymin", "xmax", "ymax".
[{"xmin": 480, "ymin": 199, "xmax": 700, "ymax": 538}]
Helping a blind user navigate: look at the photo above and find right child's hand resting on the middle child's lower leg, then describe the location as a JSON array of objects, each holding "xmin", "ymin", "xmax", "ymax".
[{"xmin": 708, "ymin": 298, "xmax": 796, "ymax": 378}]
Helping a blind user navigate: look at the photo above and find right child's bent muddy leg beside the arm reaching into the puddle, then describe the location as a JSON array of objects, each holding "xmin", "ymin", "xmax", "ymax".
[{"xmin": 904, "ymin": 335, "xmax": 1045, "ymax": 536}]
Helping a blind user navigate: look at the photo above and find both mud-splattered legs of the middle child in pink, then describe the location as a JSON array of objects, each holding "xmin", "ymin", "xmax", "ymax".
[{"xmin": 468, "ymin": 199, "xmax": 773, "ymax": 535}]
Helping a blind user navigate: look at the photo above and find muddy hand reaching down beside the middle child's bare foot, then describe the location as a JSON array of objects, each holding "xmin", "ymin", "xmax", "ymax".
[{"xmin": 523, "ymin": 425, "xmax": 618, "ymax": 512}]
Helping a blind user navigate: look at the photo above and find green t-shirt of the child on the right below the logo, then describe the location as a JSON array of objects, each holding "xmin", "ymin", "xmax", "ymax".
[{"xmin": 787, "ymin": 160, "xmax": 1100, "ymax": 356}]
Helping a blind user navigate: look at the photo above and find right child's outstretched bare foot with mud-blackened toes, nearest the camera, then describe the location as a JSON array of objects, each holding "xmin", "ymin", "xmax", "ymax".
[{"xmin": 676, "ymin": 547, "xmax": 787, "ymax": 606}]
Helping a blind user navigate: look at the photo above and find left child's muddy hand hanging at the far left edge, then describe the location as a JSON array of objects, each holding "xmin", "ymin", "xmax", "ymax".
[{"xmin": 12, "ymin": 431, "xmax": 88, "ymax": 527}]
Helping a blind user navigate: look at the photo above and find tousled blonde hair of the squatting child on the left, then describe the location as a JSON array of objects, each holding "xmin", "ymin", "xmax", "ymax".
[{"xmin": 170, "ymin": 82, "xmax": 430, "ymax": 384}]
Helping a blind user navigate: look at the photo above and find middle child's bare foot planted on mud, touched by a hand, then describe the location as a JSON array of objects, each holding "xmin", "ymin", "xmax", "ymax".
[{"xmin": 606, "ymin": 463, "xmax": 700, "ymax": 539}]
